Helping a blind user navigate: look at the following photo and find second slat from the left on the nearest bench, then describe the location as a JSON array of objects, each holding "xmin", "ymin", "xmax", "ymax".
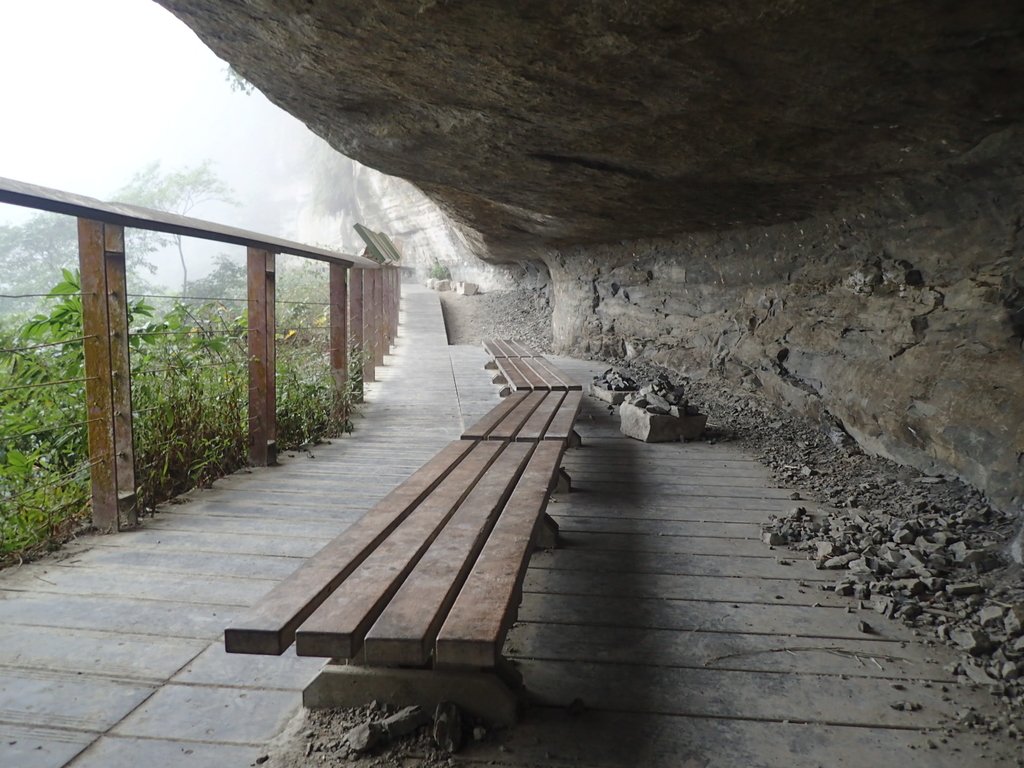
[{"xmin": 295, "ymin": 440, "xmax": 508, "ymax": 658}]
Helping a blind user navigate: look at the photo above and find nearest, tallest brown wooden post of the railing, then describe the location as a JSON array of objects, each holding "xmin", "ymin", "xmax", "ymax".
[{"xmin": 78, "ymin": 219, "xmax": 137, "ymax": 532}]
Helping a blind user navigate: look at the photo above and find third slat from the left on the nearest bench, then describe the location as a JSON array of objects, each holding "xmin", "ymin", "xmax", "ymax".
[{"xmin": 364, "ymin": 444, "xmax": 532, "ymax": 667}]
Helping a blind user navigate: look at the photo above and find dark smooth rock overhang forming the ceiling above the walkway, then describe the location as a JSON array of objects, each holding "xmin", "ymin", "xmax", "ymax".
[{"xmin": 151, "ymin": 0, "xmax": 1024, "ymax": 260}]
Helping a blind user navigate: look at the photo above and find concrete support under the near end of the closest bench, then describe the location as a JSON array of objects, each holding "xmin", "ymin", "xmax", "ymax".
[{"xmin": 302, "ymin": 662, "xmax": 522, "ymax": 726}]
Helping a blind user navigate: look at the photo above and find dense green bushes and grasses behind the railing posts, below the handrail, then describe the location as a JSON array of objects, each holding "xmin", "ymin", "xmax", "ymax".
[{"xmin": 0, "ymin": 269, "xmax": 351, "ymax": 561}]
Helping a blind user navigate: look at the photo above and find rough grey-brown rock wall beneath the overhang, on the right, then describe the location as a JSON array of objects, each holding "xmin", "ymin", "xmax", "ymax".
[{"xmin": 548, "ymin": 143, "xmax": 1024, "ymax": 518}]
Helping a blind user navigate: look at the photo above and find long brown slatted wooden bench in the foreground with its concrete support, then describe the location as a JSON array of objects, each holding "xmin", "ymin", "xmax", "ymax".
[{"xmin": 224, "ymin": 339, "xmax": 582, "ymax": 723}]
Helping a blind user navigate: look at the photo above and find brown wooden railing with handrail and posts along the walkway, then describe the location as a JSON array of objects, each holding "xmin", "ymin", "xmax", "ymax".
[{"xmin": 0, "ymin": 177, "xmax": 401, "ymax": 531}]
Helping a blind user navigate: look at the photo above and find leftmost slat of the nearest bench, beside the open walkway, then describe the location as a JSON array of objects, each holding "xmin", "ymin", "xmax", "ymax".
[{"xmin": 224, "ymin": 440, "xmax": 476, "ymax": 655}]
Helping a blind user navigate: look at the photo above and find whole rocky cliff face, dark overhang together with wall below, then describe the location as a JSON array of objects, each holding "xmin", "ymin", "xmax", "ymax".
[{"xmin": 153, "ymin": 0, "xmax": 1024, "ymax": 518}]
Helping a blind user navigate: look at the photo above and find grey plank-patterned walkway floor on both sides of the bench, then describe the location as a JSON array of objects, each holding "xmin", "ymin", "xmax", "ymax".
[{"xmin": 0, "ymin": 287, "xmax": 1007, "ymax": 768}]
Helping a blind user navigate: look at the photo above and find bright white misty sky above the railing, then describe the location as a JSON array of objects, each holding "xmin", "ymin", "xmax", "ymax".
[{"xmin": 0, "ymin": 0, "xmax": 350, "ymax": 286}]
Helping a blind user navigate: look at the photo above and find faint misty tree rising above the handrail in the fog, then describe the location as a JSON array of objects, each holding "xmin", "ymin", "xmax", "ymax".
[{"xmin": 115, "ymin": 160, "xmax": 238, "ymax": 296}]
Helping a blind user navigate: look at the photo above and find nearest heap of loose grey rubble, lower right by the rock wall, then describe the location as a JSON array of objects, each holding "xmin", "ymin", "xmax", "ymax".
[{"xmin": 763, "ymin": 500, "xmax": 1024, "ymax": 707}]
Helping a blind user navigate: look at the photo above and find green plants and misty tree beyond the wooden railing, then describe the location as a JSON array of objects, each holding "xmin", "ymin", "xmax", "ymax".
[{"xmin": 0, "ymin": 165, "xmax": 358, "ymax": 565}]
